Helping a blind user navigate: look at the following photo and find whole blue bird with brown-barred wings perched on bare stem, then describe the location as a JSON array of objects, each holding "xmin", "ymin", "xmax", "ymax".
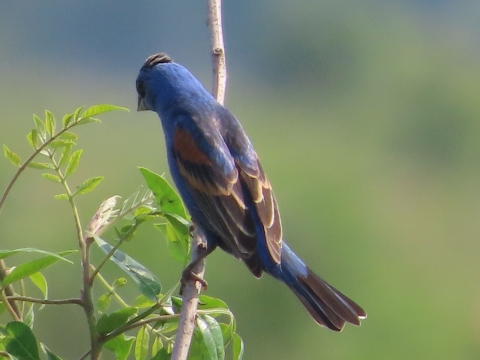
[{"xmin": 136, "ymin": 53, "xmax": 366, "ymax": 331}]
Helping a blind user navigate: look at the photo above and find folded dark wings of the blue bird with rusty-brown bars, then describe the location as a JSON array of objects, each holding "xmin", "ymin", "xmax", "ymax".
[{"xmin": 173, "ymin": 112, "xmax": 281, "ymax": 276}]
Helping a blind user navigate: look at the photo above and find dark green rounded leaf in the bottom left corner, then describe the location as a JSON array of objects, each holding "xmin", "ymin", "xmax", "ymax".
[{"xmin": 3, "ymin": 321, "xmax": 40, "ymax": 360}]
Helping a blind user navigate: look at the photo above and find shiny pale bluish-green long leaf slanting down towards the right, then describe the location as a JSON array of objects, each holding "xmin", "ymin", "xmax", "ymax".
[{"xmin": 94, "ymin": 235, "xmax": 162, "ymax": 302}]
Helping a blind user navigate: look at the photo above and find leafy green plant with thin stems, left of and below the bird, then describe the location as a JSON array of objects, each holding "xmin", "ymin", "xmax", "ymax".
[{"xmin": 0, "ymin": 104, "xmax": 243, "ymax": 360}]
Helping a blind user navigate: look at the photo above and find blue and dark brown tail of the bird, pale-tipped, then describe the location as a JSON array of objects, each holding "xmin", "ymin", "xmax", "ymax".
[{"xmin": 277, "ymin": 243, "xmax": 367, "ymax": 331}]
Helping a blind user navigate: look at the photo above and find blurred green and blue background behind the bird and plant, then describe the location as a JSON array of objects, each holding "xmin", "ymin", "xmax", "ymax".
[{"xmin": 0, "ymin": 0, "xmax": 480, "ymax": 359}]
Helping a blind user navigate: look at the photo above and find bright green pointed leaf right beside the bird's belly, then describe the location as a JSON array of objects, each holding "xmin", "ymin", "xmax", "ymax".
[{"xmin": 139, "ymin": 167, "xmax": 187, "ymax": 218}]
